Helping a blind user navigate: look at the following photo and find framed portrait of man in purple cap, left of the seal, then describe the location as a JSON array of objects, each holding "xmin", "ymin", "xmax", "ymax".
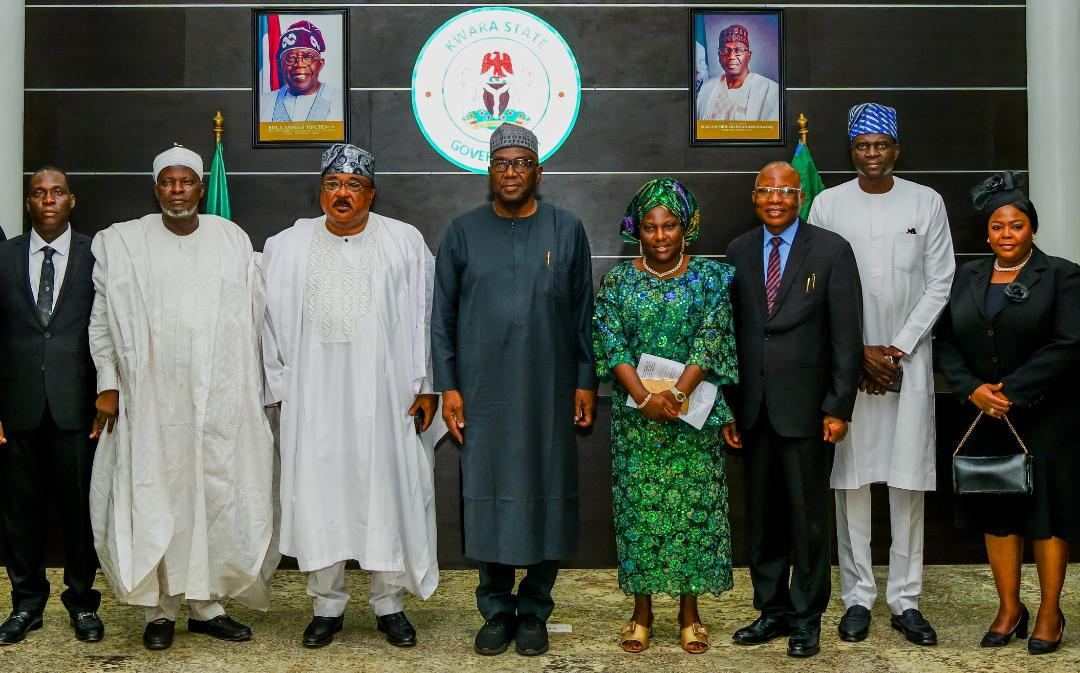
[{"xmin": 252, "ymin": 9, "xmax": 349, "ymax": 147}]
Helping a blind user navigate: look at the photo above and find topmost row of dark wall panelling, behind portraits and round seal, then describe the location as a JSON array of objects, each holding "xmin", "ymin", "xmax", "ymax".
[{"xmin": 26, "ymin": 3, "xmax": 1026, "ymax": 88}]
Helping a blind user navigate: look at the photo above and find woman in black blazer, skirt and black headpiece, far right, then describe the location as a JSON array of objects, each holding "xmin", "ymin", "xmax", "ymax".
[{"xmin": 935, "ymin": 173, "xmax": 1080, "ymax": 655}]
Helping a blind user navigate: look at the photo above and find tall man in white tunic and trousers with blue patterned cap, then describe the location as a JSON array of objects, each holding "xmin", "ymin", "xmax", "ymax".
[{"xmin": 809, "ymin": 103, "xmax": 956, "ymax": 645}]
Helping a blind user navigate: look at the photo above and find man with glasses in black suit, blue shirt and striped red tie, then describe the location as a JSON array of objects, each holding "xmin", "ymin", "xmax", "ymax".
[{"xmin": 724, "ymin": 162, "xmax": 863, "ymax": 657}]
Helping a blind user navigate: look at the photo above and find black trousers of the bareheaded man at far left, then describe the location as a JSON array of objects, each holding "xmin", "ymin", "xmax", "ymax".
[{"xmin": 0, "ymin": 409, "xmax": 102, "ymax": 615}]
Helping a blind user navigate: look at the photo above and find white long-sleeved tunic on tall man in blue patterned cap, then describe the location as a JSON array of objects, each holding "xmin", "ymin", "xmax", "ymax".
[{"xmin": 809, "ymin": 177, "xmax": 956, "ymax": 490}]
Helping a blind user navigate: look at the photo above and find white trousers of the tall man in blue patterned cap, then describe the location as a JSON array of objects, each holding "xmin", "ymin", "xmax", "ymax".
[{"xmin": 835, "ymin": 484, "xmax": 924, "ymax": 615}]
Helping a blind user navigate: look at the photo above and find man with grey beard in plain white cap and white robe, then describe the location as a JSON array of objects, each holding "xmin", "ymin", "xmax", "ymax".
[{"xmin": 90, "ymin": 147, "xmax": 279, "ymax": 649}]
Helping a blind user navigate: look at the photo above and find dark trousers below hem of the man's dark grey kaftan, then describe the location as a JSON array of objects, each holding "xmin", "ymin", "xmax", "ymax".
[{"xmin": 476, "ymin": 561, "xmax": 558, "ymax": 621}]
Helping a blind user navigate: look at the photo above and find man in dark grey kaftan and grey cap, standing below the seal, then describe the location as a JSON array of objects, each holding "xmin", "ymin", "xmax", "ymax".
[{"xmin": 431, "ymin": 124, "xmax": 596, "ymax": 655}]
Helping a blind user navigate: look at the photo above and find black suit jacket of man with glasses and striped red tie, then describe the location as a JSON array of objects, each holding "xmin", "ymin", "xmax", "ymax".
[{"xmin": 727, "ymin": 223, "xmax": 863, "ymax": 438}]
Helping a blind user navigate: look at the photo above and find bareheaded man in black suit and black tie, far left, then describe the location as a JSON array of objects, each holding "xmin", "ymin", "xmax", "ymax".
[{"xmin": 0, "ymin": 167, "xmax": 105, "ymax": 645}]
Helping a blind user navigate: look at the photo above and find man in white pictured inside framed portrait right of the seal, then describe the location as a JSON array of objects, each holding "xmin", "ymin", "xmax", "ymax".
[{"xmin": 697, "ymin": 24, "xmax": 780, "ymax": 121}]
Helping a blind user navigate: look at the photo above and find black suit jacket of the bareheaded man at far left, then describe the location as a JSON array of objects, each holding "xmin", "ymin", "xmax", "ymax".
[{"xmin": 0, "ymin": 230, "xmax": 96, "ymax": 432}]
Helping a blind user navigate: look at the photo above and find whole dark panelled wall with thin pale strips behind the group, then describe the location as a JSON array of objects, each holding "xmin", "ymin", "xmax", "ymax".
[{"xmin": 25, "ymin": 0, "xmax": 1027, "ymax": 567}]
